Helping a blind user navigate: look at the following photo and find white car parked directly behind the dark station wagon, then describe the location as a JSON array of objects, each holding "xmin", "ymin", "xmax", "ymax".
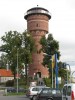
[{"xmin": 26, "ymin": 86, "xmax": 46, "ymax": 100}]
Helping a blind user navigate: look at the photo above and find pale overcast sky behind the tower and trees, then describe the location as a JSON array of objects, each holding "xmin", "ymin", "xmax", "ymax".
[{"xmin": 0, "ymin": 0, "xmax": 75, "ymax": 74}]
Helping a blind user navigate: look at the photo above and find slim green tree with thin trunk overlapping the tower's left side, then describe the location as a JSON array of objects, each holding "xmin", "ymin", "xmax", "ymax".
[{"xmin": 21, "ymin": 31, "xmax": 36, "ymax": 84}]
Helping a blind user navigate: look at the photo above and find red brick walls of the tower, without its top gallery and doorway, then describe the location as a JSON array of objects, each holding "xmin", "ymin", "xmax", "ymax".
[{"xmin": 27, "ymin": 14, "xmax": 49, "ymax": 77}]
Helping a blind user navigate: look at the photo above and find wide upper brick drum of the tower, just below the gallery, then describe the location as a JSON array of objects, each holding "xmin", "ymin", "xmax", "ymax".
[{"xmin": 27, "ymin": 15, "xmax": 48, "ymax": 32}]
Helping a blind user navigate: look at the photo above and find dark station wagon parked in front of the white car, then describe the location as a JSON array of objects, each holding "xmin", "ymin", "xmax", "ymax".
[{"xmin": 36, "ymin": 88, "xmax": 62, "ymax": 100}]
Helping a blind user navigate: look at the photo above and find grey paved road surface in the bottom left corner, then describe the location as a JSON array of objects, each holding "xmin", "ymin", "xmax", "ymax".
[{"xmin": 0, "ymin": 96, "xmax": 29, "ymax": 100}]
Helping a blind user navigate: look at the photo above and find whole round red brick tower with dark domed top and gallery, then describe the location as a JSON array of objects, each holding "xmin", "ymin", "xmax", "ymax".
[{"xmin": 24, "ymin": 6, "xmax": 51, "ymax": 78}]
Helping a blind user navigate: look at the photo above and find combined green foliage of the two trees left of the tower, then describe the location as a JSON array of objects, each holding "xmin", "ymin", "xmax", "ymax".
[{"xmin": 0, "ymin": 31, "xmax": 34, "ymax": 81}]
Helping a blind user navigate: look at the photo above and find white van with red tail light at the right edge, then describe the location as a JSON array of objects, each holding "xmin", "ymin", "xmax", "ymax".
[{"xmin": 62, "ymin": 83, "xmax": 75, "ymax": 100}]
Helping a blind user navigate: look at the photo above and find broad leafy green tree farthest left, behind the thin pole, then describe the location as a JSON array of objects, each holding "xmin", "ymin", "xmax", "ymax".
[{"xmin": 0, "ymin": 31, "xmax": 22, "ymax": 78}]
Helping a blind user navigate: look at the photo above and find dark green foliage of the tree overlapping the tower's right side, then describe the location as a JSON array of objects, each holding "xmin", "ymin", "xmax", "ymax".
[{"xmin": 40, "ymin": 34, "xmax": 60, "ymax": 67}]
